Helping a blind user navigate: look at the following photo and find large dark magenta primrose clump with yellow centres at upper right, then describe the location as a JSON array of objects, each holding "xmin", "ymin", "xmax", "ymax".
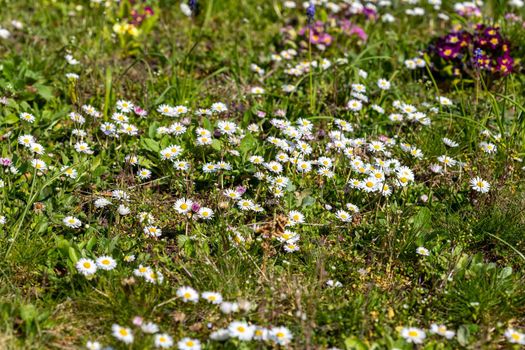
[{"xmin": 428, "ymin": 24, "xmax": 514, "ymax": 76}]
